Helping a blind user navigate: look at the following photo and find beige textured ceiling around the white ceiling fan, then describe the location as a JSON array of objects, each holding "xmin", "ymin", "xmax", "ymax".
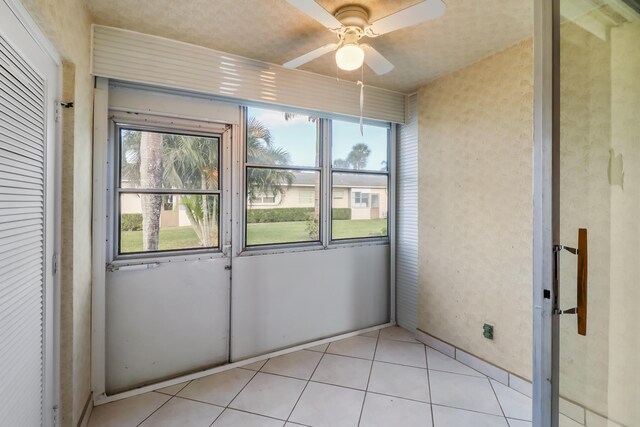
[{"xmin": 85, "ymin": 0, "xmax": 533, "ymax": 93}]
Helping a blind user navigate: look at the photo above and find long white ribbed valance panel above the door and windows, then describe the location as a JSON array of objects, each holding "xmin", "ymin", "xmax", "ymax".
[{"xmin": 91, "ymin": 25, "xmax": 405, "ymax": 123}]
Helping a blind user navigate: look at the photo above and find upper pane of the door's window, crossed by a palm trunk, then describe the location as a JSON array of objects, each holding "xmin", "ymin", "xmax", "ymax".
[{"xmin": 120, "ymin": 129, "xmax": 219, "ymax": 190}]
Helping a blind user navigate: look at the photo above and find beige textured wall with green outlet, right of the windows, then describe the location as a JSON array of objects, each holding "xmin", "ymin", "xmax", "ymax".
[{"xmin": 418, "ymin": 40, "xmax": 533, "ymax": 379}]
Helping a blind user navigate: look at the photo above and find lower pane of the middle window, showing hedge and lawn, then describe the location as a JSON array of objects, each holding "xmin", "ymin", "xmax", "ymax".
[{"xmin": 246, "ymin": 168, "xmax": 320, "ymax": 246}]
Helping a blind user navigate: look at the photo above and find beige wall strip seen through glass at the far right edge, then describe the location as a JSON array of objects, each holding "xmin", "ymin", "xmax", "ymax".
[{"xmin": 595, "ymin": 21, "xmax": 640, "ymax": 426}]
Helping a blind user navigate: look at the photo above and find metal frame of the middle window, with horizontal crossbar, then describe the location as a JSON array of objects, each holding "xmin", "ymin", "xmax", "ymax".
[{"xmin": 241, "ymin": 105, "xmax": 327, "ymax": 252}]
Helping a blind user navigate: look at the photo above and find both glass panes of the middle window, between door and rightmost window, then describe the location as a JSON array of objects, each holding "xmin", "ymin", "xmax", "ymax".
[{"xmin": 245, "ymin": 107, "xmax": 321, "ymax": 246}]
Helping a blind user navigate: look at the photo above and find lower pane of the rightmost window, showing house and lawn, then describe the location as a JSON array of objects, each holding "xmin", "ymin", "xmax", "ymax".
[{"xmin": 331, "ymin": 172, "xmax": 388, "ymax": 240}]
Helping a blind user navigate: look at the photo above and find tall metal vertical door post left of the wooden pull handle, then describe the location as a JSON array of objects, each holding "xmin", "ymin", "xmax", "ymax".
[{"xmin": 533, "ymin": 0, "xmax": 560, "ymax": 427}]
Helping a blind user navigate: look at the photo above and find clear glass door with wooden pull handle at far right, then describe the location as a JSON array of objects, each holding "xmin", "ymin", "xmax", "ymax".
[{"xmin": 554, "ymin": 0, "xmax": 640, "ymax": 427}]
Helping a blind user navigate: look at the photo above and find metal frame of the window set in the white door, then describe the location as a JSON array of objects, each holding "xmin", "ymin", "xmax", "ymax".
[{"xmin": 114, "ymin": 122, "xmax": 226, "ymax": 261}]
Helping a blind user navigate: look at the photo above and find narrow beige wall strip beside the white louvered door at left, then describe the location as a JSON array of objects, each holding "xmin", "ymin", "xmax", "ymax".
[{"xmin": 22, "ymin": 0, "xmax": 93, "ymax": 426}]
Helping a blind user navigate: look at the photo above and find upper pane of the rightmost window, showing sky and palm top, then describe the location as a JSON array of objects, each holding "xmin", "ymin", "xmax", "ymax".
[{"xmin": 331, "ymin": 120, "xmax": 389, "ymax": 171}]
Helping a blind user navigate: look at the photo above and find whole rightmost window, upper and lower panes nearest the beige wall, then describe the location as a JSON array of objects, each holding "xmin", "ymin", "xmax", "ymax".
[{"xmin": 331, "ymin": 120, "xmax": 390, "ymax": 240}]
